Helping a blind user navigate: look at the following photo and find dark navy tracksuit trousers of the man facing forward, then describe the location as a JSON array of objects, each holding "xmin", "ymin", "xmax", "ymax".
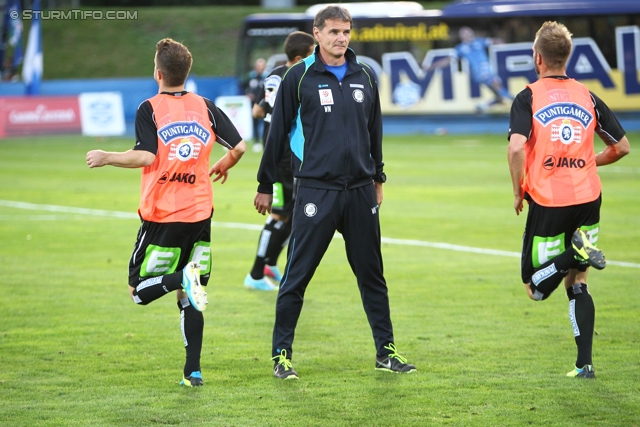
[{"xmin": 272, "ymin": 184, "xmax": 394, "ymax": 357}]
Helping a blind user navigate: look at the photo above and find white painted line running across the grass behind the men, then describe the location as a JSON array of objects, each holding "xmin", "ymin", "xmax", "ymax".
[{"xmin": 0, "ymin": 200, "xmax": 640, "ymax": 268}]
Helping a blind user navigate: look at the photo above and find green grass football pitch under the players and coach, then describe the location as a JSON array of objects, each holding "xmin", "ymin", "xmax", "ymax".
[{"xmin": 0, "ymin": 131, "xmax": 640, "ymax": 427}]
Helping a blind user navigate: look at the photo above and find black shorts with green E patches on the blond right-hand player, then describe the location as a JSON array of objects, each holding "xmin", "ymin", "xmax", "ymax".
[{"xmin": 521, "ymin": 196, "xmax": 602, "ymax": 283}]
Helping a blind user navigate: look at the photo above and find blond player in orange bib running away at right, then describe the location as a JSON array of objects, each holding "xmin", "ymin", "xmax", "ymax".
[{"xmin": 508, "ymin": 22, "xmax": 629, "ymax": 378}]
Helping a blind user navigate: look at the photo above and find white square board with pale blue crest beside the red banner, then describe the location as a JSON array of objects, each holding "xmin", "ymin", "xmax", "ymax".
[{"xmin": 79, "ymin": 92, "xmax": 126, "ymax": 136}]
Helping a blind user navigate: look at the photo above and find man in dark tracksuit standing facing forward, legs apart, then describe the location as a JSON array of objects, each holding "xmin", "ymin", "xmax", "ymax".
[{"xmin": 254, "ymin": 6, "xmax": 416, "ymax": 379}]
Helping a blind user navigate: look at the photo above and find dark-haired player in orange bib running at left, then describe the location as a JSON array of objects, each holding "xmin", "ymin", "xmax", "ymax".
[{"xmin": 87, "ymin": 38, "xmax": 246, "ymax": 387}]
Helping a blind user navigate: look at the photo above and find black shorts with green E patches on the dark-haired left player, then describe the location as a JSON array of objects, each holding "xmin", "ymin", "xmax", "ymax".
[{"xmin": 129, "ymin": 218, "xmax": 211, "ymax": 287}]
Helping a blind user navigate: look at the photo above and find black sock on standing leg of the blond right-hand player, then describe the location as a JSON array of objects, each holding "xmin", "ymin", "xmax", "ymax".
[{"xmin": 567, "ymin": 283, "xmax": 596, "ymax": 368}]
